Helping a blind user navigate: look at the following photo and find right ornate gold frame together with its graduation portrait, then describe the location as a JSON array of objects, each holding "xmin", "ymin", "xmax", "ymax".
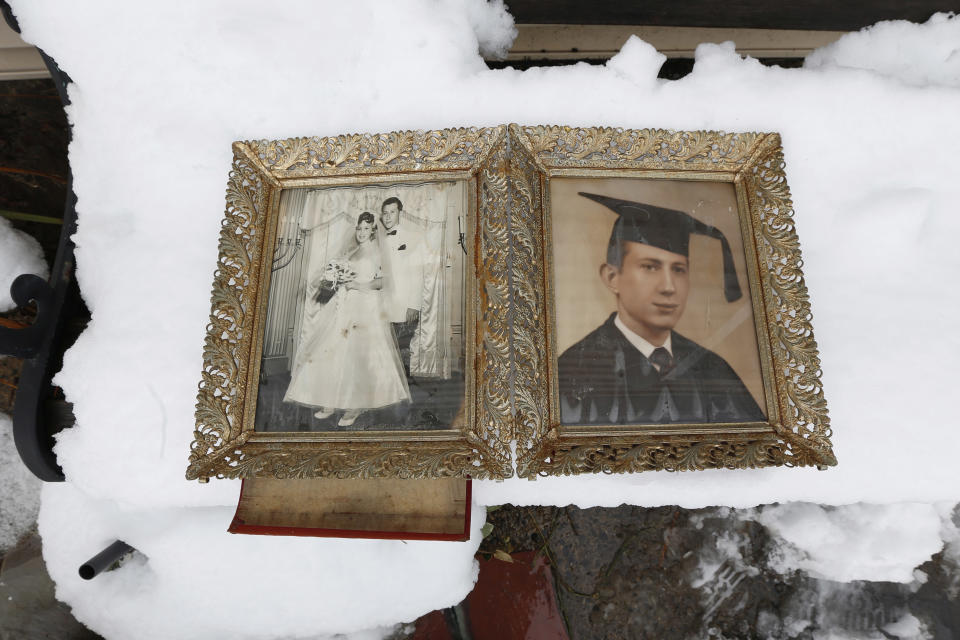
[{"xmin": 510, "ymin": 125, "xmax": 836, "ymax": 477}]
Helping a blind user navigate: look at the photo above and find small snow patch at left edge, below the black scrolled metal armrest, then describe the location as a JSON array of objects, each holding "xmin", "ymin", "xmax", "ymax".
[{"xmin": 0, "ymin": 412, "xmax": 41, "ymax": 557}]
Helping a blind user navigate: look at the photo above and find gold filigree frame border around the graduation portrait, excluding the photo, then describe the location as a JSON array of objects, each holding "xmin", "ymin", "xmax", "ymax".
[{"xmin": 509, "ymin": 125, "xmax": 836, "ymax": 477}]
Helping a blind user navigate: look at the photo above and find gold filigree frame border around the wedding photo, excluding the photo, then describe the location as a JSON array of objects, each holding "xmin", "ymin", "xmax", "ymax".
[{"xmin": 186, "ymin": 127, "xmax": 513, "ymax": 481}]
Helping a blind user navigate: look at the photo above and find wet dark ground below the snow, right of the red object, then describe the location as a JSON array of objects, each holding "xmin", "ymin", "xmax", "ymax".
[{"xmin": 472, "ymin": 506, "xmax": 960, "ymax": 640}]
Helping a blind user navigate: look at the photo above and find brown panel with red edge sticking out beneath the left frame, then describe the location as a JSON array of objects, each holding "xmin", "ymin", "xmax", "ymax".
[{"xmin": 230, "ymin": 478, "xmax": 469, "ymax": 539}]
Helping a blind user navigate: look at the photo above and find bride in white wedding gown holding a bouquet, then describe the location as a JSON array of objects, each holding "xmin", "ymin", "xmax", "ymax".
[{"xmin": 283, "ymin": 211, "xmax": 410, "ymax": 427}]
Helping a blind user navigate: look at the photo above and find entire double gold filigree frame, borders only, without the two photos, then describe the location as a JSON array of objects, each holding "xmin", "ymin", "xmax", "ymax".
[{"xmin": 186, "ymin": 125, "xmax": 836, "ymax": 481}]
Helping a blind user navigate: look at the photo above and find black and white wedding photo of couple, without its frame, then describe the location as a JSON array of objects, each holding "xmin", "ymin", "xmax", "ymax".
[{"xmin": 255, "ymin": 182, "xmax": 466, "ymax": 432}]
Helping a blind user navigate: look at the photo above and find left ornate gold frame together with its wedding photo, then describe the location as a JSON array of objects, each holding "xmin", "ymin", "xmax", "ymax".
[{"xmin": 186, "ymin": 127, "xmax": 513, "ymax": 481}]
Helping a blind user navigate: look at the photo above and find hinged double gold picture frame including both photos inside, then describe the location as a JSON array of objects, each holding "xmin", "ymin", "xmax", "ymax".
[{"xmin": 186, "ymin": 125, "xmax": 836, "ymax": 481}]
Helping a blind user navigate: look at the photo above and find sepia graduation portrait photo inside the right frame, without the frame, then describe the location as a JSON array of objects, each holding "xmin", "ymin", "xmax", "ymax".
[{"xmin": 550, "ymin": 178, "xmax": 767, "ymax": 426}]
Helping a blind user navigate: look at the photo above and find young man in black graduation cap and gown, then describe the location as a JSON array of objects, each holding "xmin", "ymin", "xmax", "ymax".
[{"xmin": 558, "ymin": 192, "xmax": 766, "ymax": 424}]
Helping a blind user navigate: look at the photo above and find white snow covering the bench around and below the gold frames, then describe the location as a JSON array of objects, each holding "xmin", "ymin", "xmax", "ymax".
[{"xmin": 0, "ymin": 0, "xmax": 960, "ymax": 638}]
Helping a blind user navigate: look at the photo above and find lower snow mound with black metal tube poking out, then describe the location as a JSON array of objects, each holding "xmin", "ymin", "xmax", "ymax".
[{"xmin": 39, "ymin": 482, "xmax": 485, "ymax": 640}]
